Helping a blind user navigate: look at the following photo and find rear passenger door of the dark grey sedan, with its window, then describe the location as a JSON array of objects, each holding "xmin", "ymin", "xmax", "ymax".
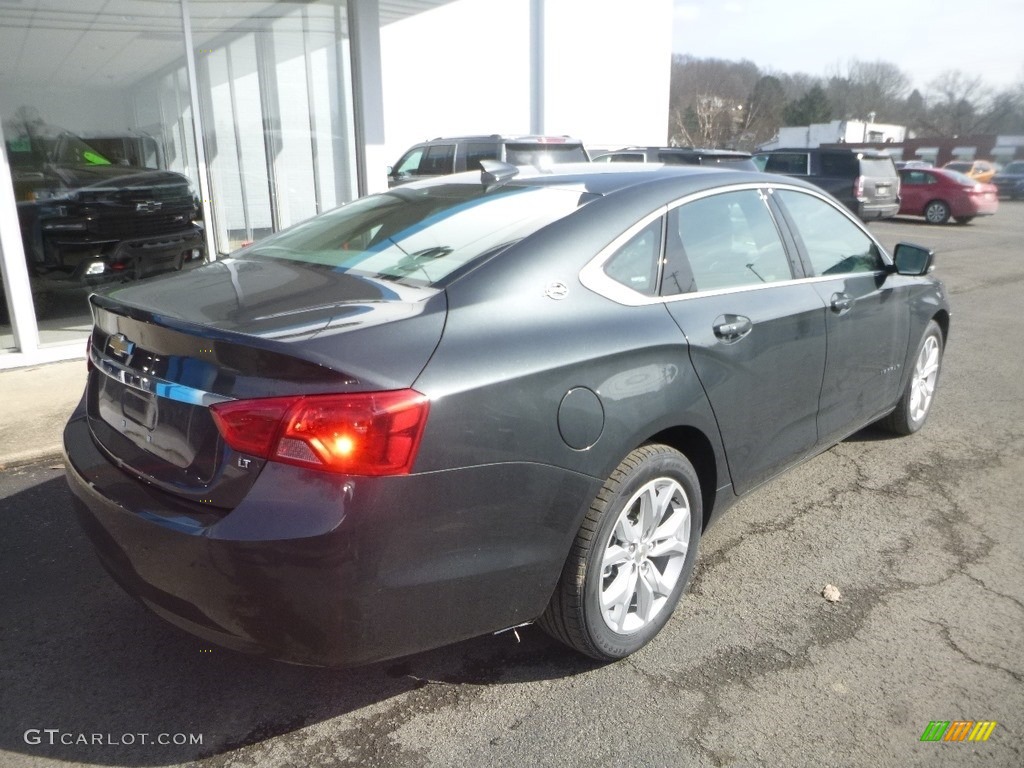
[{"xmin": 660, "ymin": 187, "xmax": 825, "ymax": 494}]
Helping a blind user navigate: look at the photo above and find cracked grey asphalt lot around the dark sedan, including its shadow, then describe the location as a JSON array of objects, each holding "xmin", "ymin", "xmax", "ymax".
[{"xmin": 0, "ymin": 201, "xmax": 1024, "ymax": 768}]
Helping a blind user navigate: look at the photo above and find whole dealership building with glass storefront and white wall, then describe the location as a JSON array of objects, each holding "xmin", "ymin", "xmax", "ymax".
[{"xmin": 0, "ymin": 0, "xmax": 673, "ymax": 369}]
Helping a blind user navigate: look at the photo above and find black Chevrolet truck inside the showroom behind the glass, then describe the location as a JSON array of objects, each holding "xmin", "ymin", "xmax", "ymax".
[{"xmin": 6, "ymin": 133, "xmax": 205, "ymax": 303}]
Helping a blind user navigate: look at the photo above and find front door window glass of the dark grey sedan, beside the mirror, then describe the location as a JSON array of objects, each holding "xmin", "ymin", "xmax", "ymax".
[{"xmin": 775, "ymin": 189, "xmax": 885, "ymax": 275}]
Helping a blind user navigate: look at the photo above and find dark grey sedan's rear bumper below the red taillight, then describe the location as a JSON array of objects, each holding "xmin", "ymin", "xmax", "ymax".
[{"xmin": 65, "ymin": 410, "xmax": 599, "ymax": 666}]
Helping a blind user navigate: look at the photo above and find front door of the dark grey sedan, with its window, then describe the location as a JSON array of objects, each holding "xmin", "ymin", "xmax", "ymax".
[{"xmin": 772, "ymin": 189, "xmax": 909, "ymax": 444}]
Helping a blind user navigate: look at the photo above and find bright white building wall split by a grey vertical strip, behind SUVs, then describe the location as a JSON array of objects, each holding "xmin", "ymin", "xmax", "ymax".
[{"xmin": 381, "ymin": 0, "xmax": 672, "ymax": 162}]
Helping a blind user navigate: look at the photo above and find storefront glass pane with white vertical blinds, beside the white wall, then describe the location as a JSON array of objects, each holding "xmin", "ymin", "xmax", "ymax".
[{"xmin": 191, "ymin": 0, "xmax": 356, "ymax": 259}]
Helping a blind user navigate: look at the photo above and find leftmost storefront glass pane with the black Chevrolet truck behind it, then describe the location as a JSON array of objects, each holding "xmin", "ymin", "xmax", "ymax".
[{"xmin": 0, "ymin": 0, "xmax": 204, "ymax": 346}]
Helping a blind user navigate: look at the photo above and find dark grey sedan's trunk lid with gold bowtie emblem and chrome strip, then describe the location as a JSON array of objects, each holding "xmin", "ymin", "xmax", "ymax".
[{"xmin": 87, "ymin": 260, "xmax": 444, "ymax": 509}]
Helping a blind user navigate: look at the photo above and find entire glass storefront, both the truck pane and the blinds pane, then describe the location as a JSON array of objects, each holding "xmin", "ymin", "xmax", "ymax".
[{"xmin": 0, "ymin": 0, "xmax": 356, "ymax": 358}]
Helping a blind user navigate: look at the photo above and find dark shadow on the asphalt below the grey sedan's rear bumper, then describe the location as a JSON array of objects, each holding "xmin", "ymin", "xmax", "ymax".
[{"xmin": 0, "ymin": 467, "xmax": 599, "ymax": 766}]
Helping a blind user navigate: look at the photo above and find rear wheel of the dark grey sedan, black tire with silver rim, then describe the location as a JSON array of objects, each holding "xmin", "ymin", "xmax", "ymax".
[{"xmin": 538, "ymin": 444, "xmax": 703, "ymax": 662}]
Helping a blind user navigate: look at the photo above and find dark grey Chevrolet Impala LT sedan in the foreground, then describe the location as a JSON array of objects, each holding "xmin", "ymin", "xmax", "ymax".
[{"xmin": 63, "ymin": 161, "xmax": 949, "ymax": 665}]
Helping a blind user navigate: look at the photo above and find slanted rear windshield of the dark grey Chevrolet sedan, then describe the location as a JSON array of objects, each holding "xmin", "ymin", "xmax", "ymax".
[{"xmin": 238, "ymin": 183, "xmax": 595, "ymax": 287}]
